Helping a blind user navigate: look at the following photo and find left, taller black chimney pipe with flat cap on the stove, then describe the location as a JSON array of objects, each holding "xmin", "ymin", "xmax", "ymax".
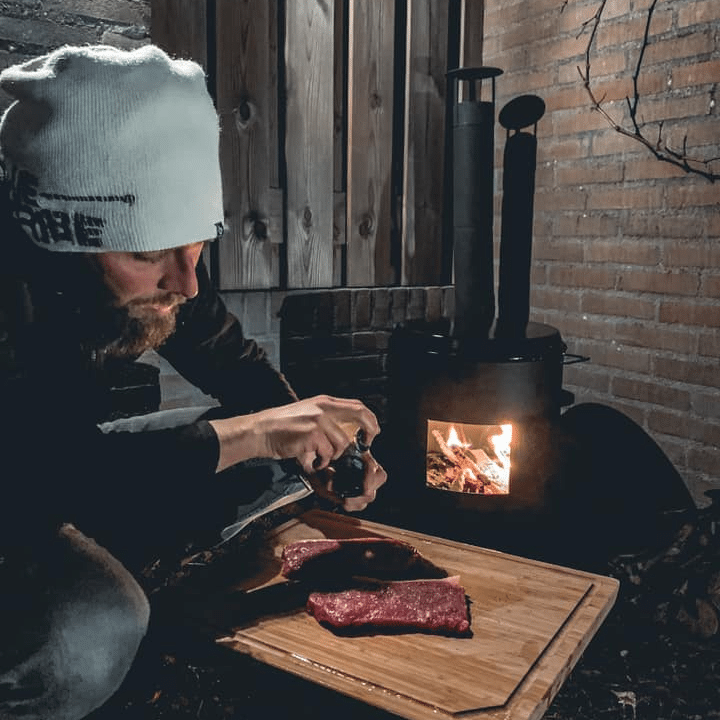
[{"xmin": 448, "ymin": 67, "xmax": 502, "ymax": 341}]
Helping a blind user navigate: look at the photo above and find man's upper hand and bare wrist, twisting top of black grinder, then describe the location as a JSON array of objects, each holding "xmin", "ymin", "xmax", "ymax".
[{"xmin": 210, "ymin": 395, "xmax": 384, "ymax": 476}]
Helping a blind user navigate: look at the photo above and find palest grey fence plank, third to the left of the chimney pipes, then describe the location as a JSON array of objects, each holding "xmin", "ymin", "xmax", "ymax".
[{"xmin": 285, "ymin": 0, "xmax": 334, "ymax": 288}]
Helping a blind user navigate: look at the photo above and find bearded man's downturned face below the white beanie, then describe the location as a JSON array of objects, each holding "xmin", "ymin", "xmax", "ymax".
[{"xmin": 91, "ymin": 242, "xmax": 205, "ymax": 354}]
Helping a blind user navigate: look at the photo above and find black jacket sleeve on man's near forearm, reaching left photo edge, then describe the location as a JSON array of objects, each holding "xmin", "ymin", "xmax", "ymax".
[{"xmin": 0, "ymin": 366, "xmax": 219, "ymax": 555}]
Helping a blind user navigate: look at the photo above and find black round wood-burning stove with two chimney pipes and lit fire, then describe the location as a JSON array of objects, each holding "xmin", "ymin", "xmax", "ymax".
[{"xmin": 374, "ymin": 68, "xmax": 582, "ymax": 549}]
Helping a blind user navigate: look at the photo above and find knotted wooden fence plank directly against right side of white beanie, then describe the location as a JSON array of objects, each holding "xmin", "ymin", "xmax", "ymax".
[{"xmin": 216, "ymin": 0, "xmax": 282, "ymax": 290}]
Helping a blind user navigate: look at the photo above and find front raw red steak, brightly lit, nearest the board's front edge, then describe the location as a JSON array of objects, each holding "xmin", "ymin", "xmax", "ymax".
[{"xmin": 307, "ymin": 576, "xmax": 470, "ymax": 636}]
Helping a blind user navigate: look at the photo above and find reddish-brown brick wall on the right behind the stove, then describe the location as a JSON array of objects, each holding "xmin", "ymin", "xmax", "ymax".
[{"xmin": 484, "ymin": 0, "xmax": 720, "ymax": 504}]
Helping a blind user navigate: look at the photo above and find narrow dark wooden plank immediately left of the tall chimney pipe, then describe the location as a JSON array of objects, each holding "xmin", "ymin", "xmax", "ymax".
[{"xmin": 401, "ymin": 0, "xmax": 448, "ymax": 285}]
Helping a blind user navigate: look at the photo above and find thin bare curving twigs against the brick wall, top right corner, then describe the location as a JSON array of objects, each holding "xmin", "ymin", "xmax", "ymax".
[{"xmin": 572, "ymin": 0, "xmax": 720, "ymax": 182}]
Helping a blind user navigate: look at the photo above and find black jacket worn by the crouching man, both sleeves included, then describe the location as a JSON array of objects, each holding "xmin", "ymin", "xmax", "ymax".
[{"xmin": 0, "ymin": 236, "xmax": 295, "ymax": 555}]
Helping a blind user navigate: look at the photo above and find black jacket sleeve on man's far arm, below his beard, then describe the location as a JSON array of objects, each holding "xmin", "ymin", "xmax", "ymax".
[{"xmin": 158, "ymin": 262, "xmax": 297, "ymax": 415}]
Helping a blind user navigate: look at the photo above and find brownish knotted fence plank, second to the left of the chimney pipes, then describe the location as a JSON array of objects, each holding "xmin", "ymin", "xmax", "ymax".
[{"xmin": 347, "ymin": 0, "xmax": 395, "ymax": 286}]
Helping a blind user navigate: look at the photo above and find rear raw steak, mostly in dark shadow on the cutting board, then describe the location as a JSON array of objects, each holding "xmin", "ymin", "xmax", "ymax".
[{"xmin": 281, "ymin": 537, "xmax": 447, "ymax": 584}]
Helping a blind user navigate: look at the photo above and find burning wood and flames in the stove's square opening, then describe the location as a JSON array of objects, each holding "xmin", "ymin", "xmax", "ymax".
[{"xmin": 427, "ymin": 420, "xmax": 512, "ymax": 495}]
